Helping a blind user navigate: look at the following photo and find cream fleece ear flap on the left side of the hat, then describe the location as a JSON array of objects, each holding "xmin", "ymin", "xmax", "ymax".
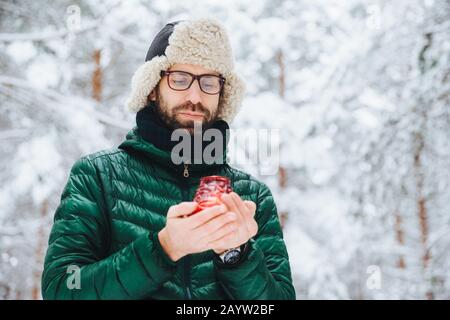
[{"xmin": 126, "ymin": 56, "xmax": 170, "ymax": 112}]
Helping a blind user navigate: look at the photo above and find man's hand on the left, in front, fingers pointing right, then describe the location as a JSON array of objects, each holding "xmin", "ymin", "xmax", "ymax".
[{"xmin": 158, "ymin": 202, "xmax": 238, "ymax": 261}]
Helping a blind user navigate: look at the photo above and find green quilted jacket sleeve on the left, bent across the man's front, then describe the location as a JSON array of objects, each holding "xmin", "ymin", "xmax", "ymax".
[{"xmin": 42, "ymin": 158, "xmax": 175, "ymax": 299}]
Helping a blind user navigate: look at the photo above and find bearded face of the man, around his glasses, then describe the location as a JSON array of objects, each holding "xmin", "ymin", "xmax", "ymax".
[{"xmin": 150, "ymin": 64, "xmax": 220, "ymax": 133}]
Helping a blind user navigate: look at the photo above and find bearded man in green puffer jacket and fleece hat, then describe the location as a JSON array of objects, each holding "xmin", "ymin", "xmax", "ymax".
[{"xmin": 42, "ymin": 19, "xmax": 295, "ymax": 299}]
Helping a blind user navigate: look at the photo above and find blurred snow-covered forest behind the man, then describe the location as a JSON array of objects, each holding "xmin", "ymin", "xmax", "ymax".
[{"xmin": 0, "ymin": 0, "xmax": 450, "ymax": 299}]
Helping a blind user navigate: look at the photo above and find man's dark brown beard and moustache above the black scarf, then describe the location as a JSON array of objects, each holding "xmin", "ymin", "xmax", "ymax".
[{"xmin": 155, "ymin": 90, "xmax": 221, "ymax": 134}]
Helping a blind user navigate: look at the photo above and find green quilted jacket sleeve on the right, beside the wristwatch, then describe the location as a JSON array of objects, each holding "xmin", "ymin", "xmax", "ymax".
[{"xmin": 215, "ymin": 184, "xmax": 295, "ymax": 300}]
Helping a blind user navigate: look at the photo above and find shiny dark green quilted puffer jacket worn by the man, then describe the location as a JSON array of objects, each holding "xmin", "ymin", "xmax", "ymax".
[{"xmin": 42, "ymin": 128, "xmax": 295, "ymax": 299}]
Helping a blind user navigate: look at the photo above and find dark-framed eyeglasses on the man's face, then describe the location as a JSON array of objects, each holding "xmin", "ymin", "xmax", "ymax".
[{"xmin": 161, "ymin": 71, "xmax": 225, "ymax": 94}]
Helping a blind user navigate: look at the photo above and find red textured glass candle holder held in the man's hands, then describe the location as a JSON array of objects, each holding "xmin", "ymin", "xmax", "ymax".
[{"xmin": 192, "ymin": 176, "xmax": 233, "ymax": 214}]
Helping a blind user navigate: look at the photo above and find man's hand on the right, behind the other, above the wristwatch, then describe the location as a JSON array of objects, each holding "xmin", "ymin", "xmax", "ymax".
[{"xmin": 210, "ymin": 192, "xmax": 258, "ymax": 254}]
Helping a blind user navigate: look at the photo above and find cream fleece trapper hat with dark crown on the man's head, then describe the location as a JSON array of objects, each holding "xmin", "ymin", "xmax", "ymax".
[{"xmin": 126, "ymin": 19, "xmax": 245, "ymax": 122}]
